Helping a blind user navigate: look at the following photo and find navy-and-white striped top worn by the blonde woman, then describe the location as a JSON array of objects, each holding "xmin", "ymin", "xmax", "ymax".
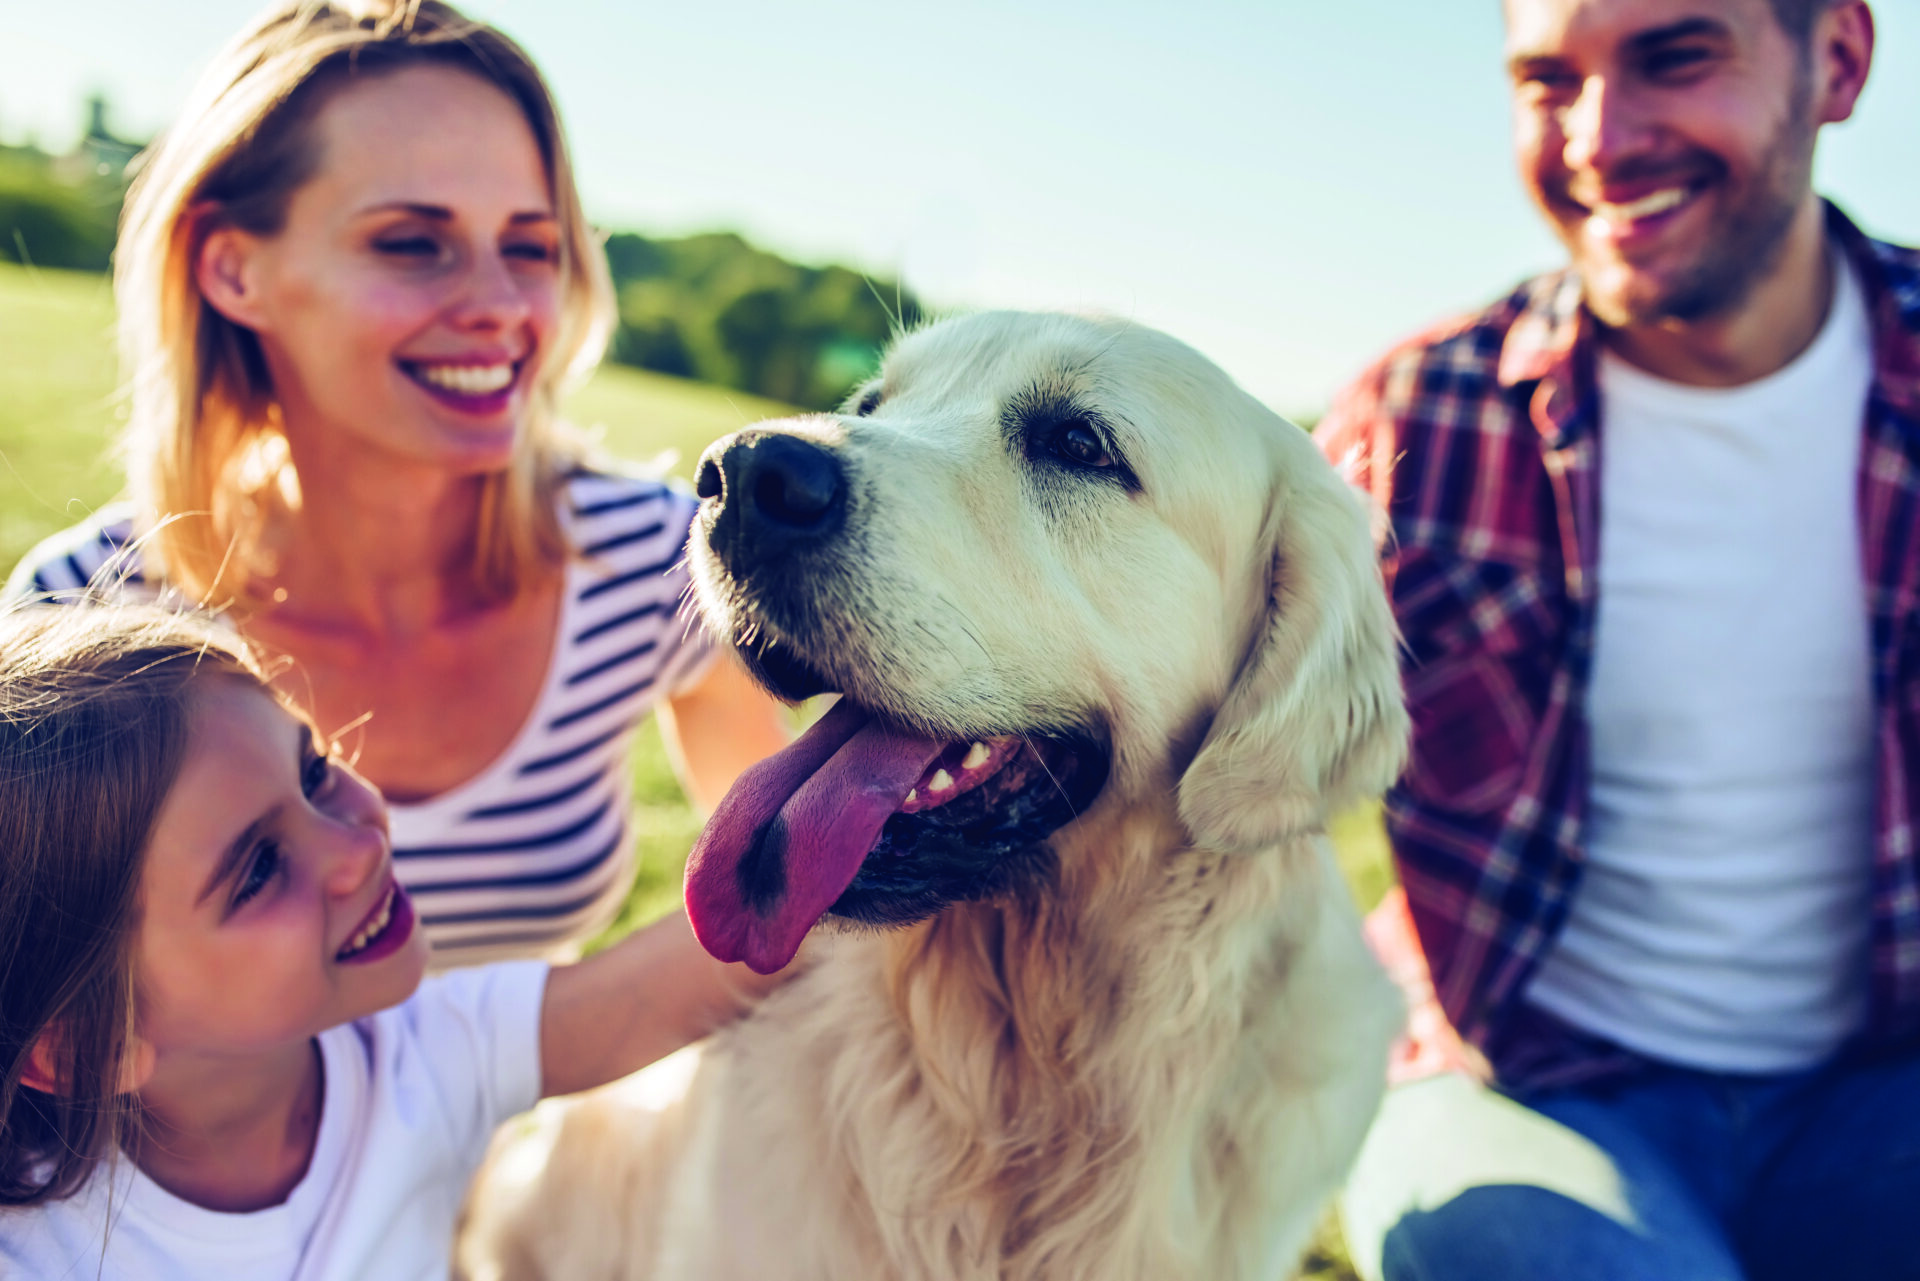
[{"xmin": 8, "ymin": 472, "xmax": 712, "ymax": 964}]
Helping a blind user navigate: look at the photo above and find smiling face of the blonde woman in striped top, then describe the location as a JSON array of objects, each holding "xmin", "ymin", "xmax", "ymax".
[{"xmin": 198, "ymin": 65, "xmax": 561, "ymax": 474}]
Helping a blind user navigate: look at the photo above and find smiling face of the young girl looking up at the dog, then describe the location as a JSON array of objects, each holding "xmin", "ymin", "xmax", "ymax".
[{"xmin": 134, "ymin": 674, "xmax": 426, "ymax": 1060}]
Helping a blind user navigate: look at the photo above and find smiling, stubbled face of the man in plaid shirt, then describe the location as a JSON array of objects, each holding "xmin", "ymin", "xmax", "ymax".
[{"xmin": 1507, "ymin": 0, "xmax": 1818, "ymax": 326}]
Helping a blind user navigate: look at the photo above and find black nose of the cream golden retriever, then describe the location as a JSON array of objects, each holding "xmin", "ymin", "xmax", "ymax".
[{"xmin": 695, "ymin": 432, "xmax": 847, "ymax": 563}]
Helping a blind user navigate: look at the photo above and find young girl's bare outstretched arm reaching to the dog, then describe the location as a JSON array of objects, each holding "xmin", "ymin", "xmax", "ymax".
[{"xmin": 540, "ymin": 912, "xmax": 797, "ymax": 1099}]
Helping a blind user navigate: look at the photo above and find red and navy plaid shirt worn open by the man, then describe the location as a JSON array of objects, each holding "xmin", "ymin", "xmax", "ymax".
[{"xmin": 1315, "ymin": 207, "xmax": 1920, "ymax": 1089}]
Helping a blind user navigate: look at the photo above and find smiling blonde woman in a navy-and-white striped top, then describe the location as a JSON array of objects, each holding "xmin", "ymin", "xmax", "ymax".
[{"xmin": 12, "ymin": 0, "xmax": 785, "ymax": 967}]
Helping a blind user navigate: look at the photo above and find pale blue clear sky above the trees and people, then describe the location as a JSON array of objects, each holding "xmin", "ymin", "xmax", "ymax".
[{"xmin": 0, "ymin": 0, "xmax": 1920, "ymax": 415}]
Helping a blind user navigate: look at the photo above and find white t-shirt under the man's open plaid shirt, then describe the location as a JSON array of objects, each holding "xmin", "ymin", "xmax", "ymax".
[{"xmin": 1526, "ymin": 259, "xmax": 1874, "ymax": 1072}]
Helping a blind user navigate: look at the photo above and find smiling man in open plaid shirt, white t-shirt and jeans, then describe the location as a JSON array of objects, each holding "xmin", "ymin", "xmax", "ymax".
[{"xmin": 1319, "ymin": 0, "xmax": 1920, "ymax": 1281}]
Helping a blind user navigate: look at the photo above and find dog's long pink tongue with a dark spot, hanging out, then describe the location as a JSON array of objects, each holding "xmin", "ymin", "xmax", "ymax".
[{"xmin": 687, "ymin": 699, "xmax": 945, "ymax": 974}]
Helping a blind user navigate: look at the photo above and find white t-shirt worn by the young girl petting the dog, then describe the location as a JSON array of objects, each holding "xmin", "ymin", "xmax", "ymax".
[{"xmin": 0, "ymin": 960, "xmax": 547, "ymax": 1281}]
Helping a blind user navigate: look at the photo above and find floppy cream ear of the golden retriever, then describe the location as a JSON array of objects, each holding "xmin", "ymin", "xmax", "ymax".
[{"xmin": 1181, "ymin": 451, "xmax": 1407, "ymax": 849}]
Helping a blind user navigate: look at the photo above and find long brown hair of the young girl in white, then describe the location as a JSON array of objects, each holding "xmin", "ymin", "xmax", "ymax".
[{"xmin": 0, "ymin": 605, "xmax": 265, "ymax": 1206}]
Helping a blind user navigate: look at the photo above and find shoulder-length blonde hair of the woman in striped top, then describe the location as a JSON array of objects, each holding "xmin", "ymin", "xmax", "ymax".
[{"xmin": 113, "ymin": 0, "xmax": 612, "ymax": 601}]
